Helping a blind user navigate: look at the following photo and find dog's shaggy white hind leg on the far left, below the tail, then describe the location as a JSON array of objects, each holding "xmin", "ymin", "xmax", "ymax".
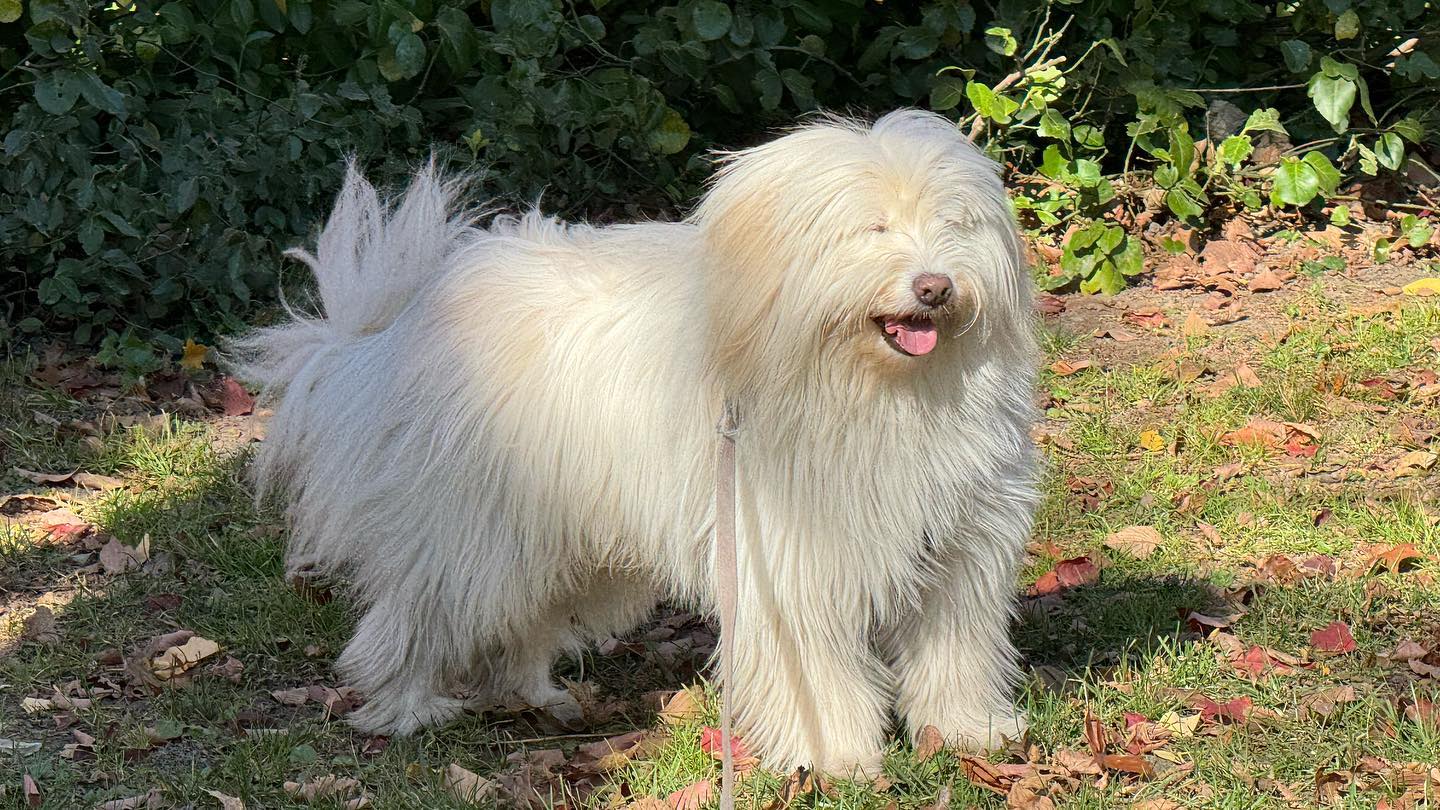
[{"xmin": 336, "ymin": 597, "xmax": 465, "ymax": 735}]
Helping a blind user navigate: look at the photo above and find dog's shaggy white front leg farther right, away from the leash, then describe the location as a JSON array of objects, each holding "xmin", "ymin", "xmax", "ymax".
[{"xmin": 890, "ymin": 543, "xmax": 1025, "ymax": 751}]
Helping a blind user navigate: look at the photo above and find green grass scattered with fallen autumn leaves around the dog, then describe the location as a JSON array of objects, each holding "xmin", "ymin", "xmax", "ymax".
[{"xmin": 0, "ymin": 281, "xmax": 1440, "ymax": 810}]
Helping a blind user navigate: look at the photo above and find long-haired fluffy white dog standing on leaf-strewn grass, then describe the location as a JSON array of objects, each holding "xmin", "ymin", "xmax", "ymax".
[{"xmin": 238, "ymin": 111, "xmax": 1037, "ymax": 773}]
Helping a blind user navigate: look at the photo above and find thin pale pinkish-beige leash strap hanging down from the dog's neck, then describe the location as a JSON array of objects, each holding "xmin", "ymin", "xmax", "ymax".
[{"xmin": 716, "ymin": 399, "xmax": 740, "ymax": 810}]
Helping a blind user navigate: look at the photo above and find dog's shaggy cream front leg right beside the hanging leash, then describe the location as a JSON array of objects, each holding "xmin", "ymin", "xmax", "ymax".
[{"xmin": 730, "ymin": 581, "xmax": 894, "ymax": 777}]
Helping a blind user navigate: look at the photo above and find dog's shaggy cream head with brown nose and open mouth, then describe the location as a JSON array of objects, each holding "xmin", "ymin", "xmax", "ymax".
[{"xmin": 693, "ymin": 110, "xmax": 1030, "ymax": 389}]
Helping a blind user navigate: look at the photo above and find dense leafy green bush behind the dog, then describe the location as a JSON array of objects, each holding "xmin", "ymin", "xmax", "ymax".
[{"xmin": 0, "ymin": 0, "xmax": 1440, "ymax": 355}]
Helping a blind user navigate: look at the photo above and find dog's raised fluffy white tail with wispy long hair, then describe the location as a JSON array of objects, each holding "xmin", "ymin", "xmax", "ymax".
[{"xmin": 229, "ymin": 161, "xmax": 478, "ymax": 396}]
